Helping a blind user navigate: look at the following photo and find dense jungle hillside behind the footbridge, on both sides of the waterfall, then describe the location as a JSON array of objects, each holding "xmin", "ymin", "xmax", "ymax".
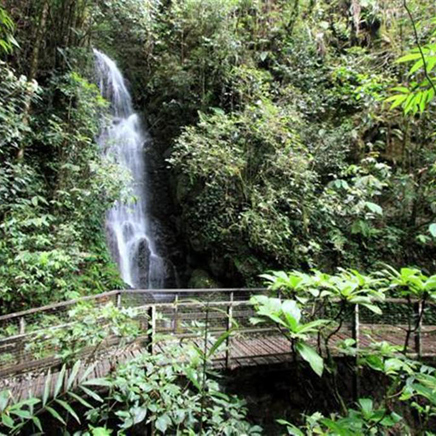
[{"xmin": 0, "ymin": 0, "xmax": 436, "ymax": 302}]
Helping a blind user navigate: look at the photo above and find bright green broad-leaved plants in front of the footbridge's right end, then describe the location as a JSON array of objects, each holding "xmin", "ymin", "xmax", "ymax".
[{"xmin": 252, "ymin": 268, "xmax": 436, "ymax": 436}]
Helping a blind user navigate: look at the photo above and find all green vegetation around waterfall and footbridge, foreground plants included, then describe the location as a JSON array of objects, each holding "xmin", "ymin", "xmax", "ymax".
[{"xmin": 0, "ymin": 0, "xmax": 436, "ymax": 436}]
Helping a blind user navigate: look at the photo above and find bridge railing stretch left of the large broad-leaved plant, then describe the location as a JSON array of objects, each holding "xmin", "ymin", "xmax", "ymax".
[{"xmin": 0, "ymin": 288, "xmax": 266, "ymax": 378}]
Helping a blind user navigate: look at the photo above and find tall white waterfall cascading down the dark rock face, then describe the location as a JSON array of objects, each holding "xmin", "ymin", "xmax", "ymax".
[{"xmin": 94, "ymin": 50, "xmax": 165, "ymax": 289}]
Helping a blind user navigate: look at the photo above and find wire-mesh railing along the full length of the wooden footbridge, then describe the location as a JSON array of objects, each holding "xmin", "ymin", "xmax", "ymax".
[{"xmin": 0, "ymin": 288, "xmax": 436, "ymax": 378}]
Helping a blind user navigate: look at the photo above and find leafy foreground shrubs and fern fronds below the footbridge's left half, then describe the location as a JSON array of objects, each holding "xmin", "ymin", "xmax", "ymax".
[{"xmin": 0, "ymin": 328, "xmax": 262, "ymax": 436}]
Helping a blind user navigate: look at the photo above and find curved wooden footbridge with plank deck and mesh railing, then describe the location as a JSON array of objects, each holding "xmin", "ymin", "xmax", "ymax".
[{"xmin": 0, "ymin": 289, "xmax": 436, "ymax": 400}]
